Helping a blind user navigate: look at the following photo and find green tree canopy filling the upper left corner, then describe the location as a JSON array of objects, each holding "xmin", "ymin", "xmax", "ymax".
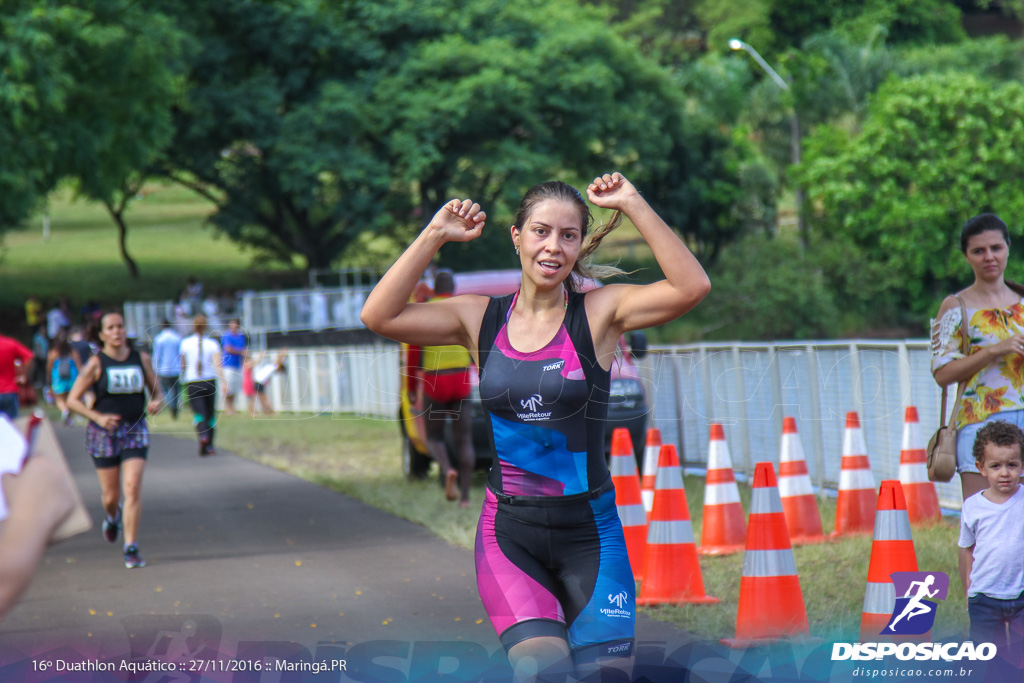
[{"xmin": 0, "ymin": 0, "xmax": 178, "ymax": 227}]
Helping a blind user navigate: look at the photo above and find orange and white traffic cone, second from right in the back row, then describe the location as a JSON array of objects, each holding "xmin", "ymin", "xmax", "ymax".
[{"xmin": 831, "ymin": 412, "xmax": 877, "ymax": 538}]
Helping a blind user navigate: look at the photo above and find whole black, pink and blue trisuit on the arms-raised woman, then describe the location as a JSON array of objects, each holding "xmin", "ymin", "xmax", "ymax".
[{"xmin": 476, "ymin": 292, "xmax": 636, "ymax": 663}]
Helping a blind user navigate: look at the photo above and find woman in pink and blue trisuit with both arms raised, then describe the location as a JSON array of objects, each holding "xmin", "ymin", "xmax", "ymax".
[{"xmin": 361, "ymin": 173, "xmax": 711, "ymax": 681}]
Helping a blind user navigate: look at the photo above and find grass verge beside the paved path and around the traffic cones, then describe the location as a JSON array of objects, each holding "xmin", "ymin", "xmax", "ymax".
[{"xmin": 146, "ymin": 415, "xmax": 968, "ymax": 642}]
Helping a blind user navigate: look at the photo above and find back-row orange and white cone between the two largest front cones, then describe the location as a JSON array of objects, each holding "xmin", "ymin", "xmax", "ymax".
[{"xmin": 697, "ymin": 423, "xmax": 746, "ymax": 555}]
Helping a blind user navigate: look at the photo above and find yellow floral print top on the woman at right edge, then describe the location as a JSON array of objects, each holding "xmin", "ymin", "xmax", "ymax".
[{"xmin": 932, "ymin": 299, "xmax": 1024, "ymax": 429}]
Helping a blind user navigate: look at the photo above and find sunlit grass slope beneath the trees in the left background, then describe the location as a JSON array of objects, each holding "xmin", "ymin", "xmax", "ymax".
[{"xmin": 0, "ymin": 184, "xmax": 304, "ymax": 321}]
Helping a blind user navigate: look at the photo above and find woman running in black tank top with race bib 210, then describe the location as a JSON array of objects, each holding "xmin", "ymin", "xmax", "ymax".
[{"xmin": 68, "ymin": 313, "xmax": 164, "ymax": 569}]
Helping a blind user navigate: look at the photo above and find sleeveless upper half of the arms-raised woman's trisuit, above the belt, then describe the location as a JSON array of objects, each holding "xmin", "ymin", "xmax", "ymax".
[{"xmin": 479, "ymin": 292, "xmax": 610, "ymax": 497}]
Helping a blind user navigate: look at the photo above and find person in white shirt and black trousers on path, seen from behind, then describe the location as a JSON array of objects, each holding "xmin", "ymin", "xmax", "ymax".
[{"xmin": 180, "ymin": 313, "xmax": 221, "ymax": 457}]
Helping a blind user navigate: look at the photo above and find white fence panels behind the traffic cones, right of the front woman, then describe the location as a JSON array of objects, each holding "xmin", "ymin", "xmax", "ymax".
[{"xmin": 642, "ymin": 340, "xmax": 962, "ymax": 508}]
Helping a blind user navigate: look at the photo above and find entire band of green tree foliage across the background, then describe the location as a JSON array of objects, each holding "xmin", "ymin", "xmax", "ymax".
[{"xmin": 0, "ymin": 0, "xmax": 1024, "ymax": 341}]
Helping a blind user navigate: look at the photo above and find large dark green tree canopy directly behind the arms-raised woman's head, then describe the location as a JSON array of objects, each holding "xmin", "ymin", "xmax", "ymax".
[{"xmin": 148, "ymin": 0, "xmax": 738, "ymax": 267}]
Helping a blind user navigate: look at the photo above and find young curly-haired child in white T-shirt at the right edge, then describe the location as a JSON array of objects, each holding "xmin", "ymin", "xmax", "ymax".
[{"xmin": 957, "ymin": 421, "xmax": 1024, "ymax": 669}]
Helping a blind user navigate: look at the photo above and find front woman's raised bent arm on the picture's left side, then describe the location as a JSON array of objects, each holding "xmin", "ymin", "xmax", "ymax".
[{"xmin": 359, "ymin": 194, "xmax": 486, "ymax": 350}]
